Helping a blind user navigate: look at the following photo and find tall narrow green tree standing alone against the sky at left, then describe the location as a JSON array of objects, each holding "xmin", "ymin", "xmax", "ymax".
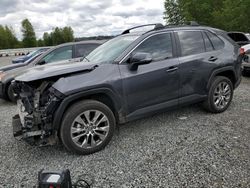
[{"xmin": 21, "ymin": 19, "xmax": 36, "ymax": 47}]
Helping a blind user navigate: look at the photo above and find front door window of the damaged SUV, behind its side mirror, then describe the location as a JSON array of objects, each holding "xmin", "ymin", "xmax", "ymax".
[{"xmin": 133, "ymin": 33, "xmax": 173, "ymax": 61}]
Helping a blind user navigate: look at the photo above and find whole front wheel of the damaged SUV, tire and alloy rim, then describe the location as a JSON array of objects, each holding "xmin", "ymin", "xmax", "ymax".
[{"xmin": 60, "ymin": 100, "xmax": 116, "ymax": 155}]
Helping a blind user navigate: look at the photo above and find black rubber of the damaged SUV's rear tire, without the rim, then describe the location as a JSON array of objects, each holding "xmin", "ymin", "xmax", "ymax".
[{"xmin": 203, "ymin": 76, "xmax": 234, "ymax": 113}]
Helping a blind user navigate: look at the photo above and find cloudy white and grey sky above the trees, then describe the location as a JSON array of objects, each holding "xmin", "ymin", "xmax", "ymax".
[{"xmin": 0, "ymin": 0, "xmax": 164, "ymax": 39}]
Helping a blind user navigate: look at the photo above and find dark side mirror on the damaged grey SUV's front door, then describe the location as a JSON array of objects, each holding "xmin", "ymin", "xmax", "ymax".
[{"xmin": 129, "ymin": 52, "xmax": 153, "ymax": 70}]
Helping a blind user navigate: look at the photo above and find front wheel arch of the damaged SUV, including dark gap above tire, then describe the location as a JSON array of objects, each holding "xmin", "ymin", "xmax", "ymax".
[{"xmin": 53, "ymin": 88, "xmax": 125, "ymax": 131}]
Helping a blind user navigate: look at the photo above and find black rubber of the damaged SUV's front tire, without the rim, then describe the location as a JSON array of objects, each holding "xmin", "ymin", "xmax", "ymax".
[{"xmin": 60, "ymin": 100, "xmax": 116, "ymax": 155}]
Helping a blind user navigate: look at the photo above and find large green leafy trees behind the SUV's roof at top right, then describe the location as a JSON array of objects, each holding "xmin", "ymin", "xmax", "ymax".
[{"xmin": 164, "ymin": 0, "xmax": 250, "ymax": 32}]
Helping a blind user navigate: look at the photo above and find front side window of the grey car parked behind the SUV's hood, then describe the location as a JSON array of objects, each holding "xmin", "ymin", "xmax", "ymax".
[{"xmin": 42, "ymin": 46, "xmax": 72, "ymax": 63}]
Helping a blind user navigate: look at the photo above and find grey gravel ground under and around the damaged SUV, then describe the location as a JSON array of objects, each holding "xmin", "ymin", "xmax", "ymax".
[{"xmin": 0, "ymin": 58, "xmax": 250, "ymax": 188}]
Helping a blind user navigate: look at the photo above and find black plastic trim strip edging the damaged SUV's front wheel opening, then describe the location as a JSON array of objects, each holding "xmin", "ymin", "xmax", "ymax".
[{"xmin": 53, "ymin": 88, "xmax": 125, "ymax": 131}]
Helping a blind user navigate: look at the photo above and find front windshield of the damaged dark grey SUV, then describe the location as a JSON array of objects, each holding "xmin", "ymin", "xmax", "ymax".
[{"xmin": 85, "ymin": 35, "xmax": 139, "ymax": 63}]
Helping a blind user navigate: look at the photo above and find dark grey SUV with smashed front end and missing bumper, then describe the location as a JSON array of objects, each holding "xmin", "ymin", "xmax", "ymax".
[{"xmin": 12, "ymin": 24, "xmax": 242, "ymax": 154}]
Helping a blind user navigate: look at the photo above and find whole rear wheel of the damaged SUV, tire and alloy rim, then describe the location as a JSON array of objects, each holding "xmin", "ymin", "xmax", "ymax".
[{"xmin": 203, "ymin": 76, "xmax": 234, "ymax": 113}]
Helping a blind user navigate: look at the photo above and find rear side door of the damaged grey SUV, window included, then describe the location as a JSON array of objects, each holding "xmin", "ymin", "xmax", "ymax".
[{"xmin": 176, "ymin": 30, "xmax": 221, "ymax": 103}]
